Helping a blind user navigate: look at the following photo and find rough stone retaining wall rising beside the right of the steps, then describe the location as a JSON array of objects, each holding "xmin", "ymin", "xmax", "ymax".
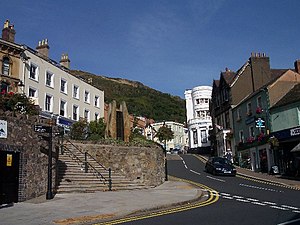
[{"xmin": 74, "ymin": 142, "xmax": 165, "ymax": 186}]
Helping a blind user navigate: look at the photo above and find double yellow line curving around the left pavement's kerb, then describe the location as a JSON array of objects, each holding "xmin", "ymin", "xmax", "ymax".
[{"xmin": 94, "ymin": 176, "xmax": 219, "ymax": 225}]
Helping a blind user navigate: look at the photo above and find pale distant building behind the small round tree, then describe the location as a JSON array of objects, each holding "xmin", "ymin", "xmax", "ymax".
[{"xmin": 145, "ymin": 121, "xmax": 188, "ymax": 151}]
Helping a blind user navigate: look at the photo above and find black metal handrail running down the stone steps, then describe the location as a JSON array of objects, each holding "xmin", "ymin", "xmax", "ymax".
[{"xmin": 64, "ymin": 139, "xmax": 112, "ymax": 191}]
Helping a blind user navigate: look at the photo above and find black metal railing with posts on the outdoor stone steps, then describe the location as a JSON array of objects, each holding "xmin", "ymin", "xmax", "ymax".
[{"xmin": 61, "ymin": 139, "xmax": 112, "ymax": 191}]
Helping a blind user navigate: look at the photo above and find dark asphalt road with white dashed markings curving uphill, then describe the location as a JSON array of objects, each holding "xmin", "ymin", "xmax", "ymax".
[{"xmin": 108, "ymin": 155, "xmax": 300, "ymax": 225}]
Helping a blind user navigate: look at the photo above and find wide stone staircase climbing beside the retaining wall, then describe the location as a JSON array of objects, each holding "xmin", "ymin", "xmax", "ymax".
[{"xmin": 57, "ymin": 142, "xmax": 147, "ymax": 193}]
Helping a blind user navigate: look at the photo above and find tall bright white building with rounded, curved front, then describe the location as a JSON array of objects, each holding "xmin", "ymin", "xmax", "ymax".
[{"xmin": 184, "ymin": 86, "xmax": 212, "ymax": 151}]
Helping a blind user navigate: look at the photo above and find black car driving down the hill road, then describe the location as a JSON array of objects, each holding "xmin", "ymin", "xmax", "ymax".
[{"xmin": 205, "ymin": 157, "xmax": 236, "ymax": 176}]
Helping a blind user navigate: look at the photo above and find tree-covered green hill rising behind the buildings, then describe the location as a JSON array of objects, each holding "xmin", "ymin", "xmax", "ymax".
[{"xmin": 71, "ymin": 70, "xmax": 186, "ymax": 123}]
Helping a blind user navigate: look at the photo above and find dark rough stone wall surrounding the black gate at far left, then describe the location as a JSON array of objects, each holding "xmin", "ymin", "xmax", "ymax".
[{"xmin": 0, "ymin": 112, "xmax": 56, "ymax": 201}]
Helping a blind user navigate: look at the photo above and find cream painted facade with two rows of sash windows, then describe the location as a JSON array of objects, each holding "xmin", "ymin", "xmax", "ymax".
[{"xmin": 20, "ymin": 46, "xmax": 104, "ymax": 126}]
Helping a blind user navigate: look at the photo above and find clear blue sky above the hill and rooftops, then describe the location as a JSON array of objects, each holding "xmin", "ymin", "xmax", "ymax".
[{"xmin": 0, "ymin": 0, "xmax": 300, "ymax": 98}]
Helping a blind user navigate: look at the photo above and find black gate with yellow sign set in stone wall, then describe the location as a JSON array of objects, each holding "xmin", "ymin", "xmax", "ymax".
[{"xmin": 0, "ymin": 149, "xmax": 20, "ymax": 204}]
